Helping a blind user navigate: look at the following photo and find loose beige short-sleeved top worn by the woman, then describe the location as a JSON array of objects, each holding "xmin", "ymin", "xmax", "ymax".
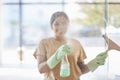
[{"xmin": 36, "ymin": 38, "xmax": 86, "ymax": 80}]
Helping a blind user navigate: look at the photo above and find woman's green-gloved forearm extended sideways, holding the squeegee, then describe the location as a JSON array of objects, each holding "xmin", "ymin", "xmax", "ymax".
[{"xmin": 77, "ymin": 51, "xmax": 107, "ymax": 74}]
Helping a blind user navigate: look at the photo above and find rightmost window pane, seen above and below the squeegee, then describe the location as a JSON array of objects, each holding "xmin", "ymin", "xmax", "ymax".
[{"xmin": 106, "ymin": 4, "xmax": 120, "ymax": 80}]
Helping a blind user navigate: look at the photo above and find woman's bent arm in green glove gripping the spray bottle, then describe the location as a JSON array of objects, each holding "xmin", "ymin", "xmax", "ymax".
[{"xmin": 37, "ymin": 44, "xmax": 70, "ymax": 73}]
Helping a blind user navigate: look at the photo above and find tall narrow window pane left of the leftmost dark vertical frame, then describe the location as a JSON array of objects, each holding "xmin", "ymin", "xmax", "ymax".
[{"xmin": 2, "ymin": 5, "xmax": 19, "ymax": 64}]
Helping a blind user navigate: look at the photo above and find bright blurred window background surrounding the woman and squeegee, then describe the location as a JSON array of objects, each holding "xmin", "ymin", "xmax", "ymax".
[{"xmin": 0, "ymin": 0, "xmax": 120, "ymax": 80}]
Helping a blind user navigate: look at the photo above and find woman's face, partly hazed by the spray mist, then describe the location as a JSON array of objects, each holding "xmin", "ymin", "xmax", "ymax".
[{"xmin": 52, "ymin": 16, "xmax": 69, "ymax": 37}]
